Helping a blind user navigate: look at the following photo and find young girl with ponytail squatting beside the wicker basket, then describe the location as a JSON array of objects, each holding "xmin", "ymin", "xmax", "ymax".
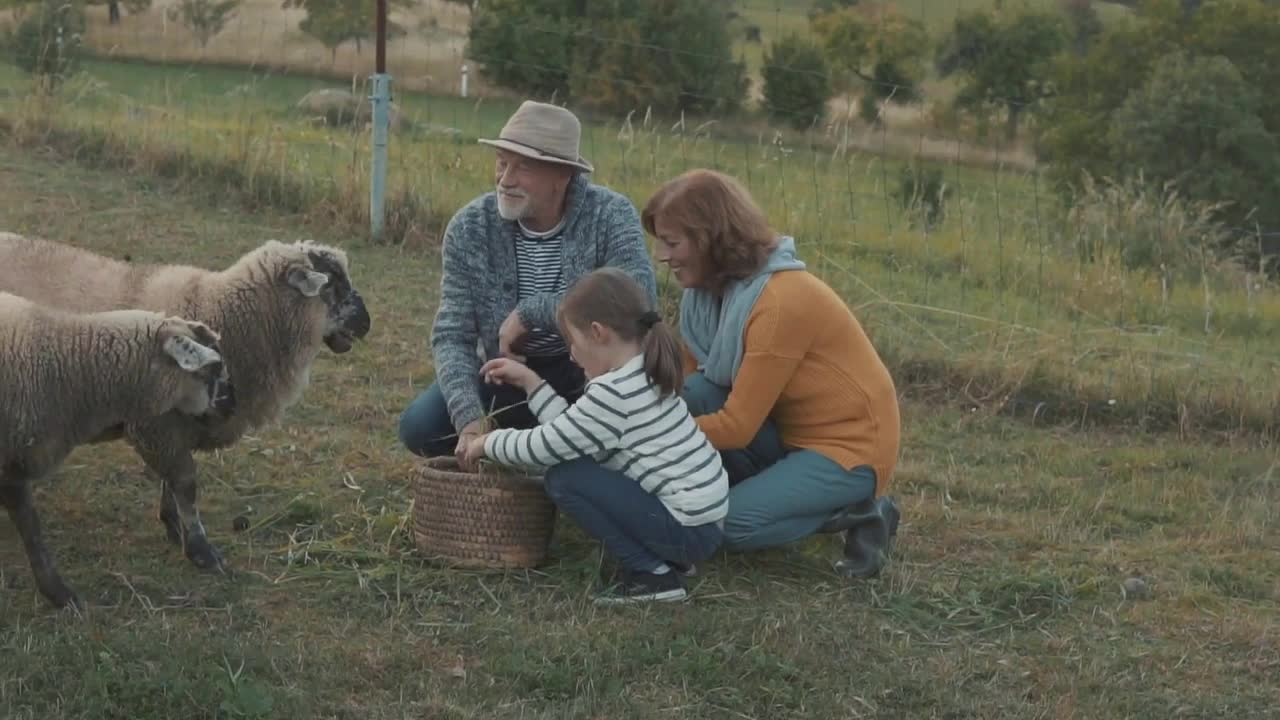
[{"xmin": 466, "ymin": 268, "xmax": 728, "ymax": 603}]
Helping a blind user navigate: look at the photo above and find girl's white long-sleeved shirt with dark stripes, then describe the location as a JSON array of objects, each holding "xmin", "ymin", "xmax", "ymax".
[{"xmin": 484, "ymin": 355, "xmax": 728, "ymax": 527}]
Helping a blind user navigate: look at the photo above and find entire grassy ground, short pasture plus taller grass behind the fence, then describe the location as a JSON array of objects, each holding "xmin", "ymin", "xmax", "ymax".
[{"xmin": 0, "ymin": 0, "xmax": 1280, "ymax": 720}]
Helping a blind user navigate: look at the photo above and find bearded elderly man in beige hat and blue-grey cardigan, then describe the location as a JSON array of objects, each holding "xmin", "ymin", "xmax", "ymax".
[{"xmin": 399, "ymin": 101, "xmax": 657, "ymax": 461}]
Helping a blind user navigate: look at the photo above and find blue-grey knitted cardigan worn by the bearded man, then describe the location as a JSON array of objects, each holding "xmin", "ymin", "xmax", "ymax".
[{"xmin": 431, "ymin": 174, "xmax": 658, "ymax": 430}]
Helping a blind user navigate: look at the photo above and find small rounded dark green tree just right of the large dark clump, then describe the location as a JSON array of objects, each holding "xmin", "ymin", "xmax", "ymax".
[{"xmin": 760, "ymin": 33, "xmax": 832, "ymax": 129}]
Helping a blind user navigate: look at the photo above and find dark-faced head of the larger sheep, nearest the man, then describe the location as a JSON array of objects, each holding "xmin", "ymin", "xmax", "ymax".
[{"xmin": 284, "ymin": 241, "xmax": 371, "ymax": 354}]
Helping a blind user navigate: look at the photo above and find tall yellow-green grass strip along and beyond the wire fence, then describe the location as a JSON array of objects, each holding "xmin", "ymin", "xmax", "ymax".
[{"xmin": 0, "ymin": 53, "xmax": 1280, "ymax": 438}]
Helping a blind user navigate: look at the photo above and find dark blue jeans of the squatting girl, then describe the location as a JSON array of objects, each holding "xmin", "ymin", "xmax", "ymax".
[{"xmin": 547, "ymin": 457, "xmax": 722, "ymax": 573}]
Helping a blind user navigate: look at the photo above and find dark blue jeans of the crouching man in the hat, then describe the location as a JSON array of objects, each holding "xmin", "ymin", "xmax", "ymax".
[{"xmin": 399, "ymin": 355, "xmax": 586, "ymax": 457}]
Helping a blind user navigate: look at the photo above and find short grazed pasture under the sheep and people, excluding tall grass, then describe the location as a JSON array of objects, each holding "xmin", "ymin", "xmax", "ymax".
[{"xmin": 0, "ymin": 131, "xmax": 1280, "ymax": 720}]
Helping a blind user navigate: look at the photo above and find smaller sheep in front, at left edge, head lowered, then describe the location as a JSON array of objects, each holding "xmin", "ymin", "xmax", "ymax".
[{"xmin": 0, "ymin": 288, "xmax": 234, "ymax": 609}]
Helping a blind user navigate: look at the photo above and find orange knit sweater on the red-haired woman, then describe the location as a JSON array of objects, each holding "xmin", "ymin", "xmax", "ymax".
[{"xmin": 685, "ymin": 270, "xmax": 900, "ymax": 495}]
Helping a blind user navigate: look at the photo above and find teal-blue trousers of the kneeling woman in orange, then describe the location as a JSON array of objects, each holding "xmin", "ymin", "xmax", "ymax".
[{"xmin": 681, "ymin": 373, "xmax": 876, "ymax": 550}]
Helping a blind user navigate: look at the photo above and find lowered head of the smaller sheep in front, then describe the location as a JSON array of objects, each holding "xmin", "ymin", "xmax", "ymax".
[{"xmin": 156, "ymin": 316, "xmax": 236, "ymax": 416}]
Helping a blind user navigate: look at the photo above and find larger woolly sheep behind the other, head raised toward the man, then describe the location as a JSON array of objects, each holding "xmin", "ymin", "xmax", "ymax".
[{"xmin": 0, "ymin": 233, "xmax": 370, "ymax": 571}]
